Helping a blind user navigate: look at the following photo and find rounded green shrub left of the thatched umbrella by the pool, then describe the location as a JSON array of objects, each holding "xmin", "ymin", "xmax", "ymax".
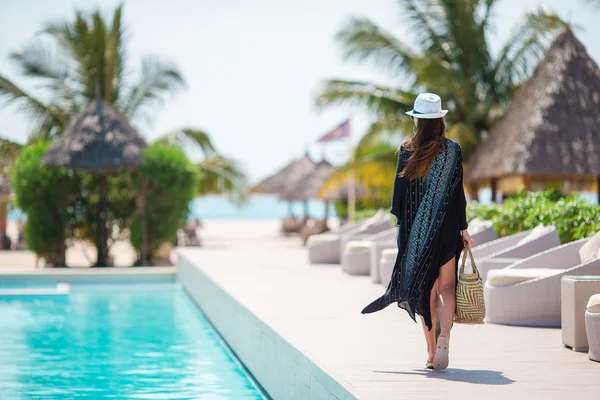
[{"xmin": 11, "ymin": 142, "xmax": 80, "ymax": 266}]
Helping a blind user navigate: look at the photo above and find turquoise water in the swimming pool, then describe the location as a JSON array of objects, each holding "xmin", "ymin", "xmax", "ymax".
[{"xmin": 0, "ymin": 283, "xmax": 263, "ymax": 400}]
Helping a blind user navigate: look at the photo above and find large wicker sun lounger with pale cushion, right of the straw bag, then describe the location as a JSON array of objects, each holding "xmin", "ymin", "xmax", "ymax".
[{"xmin": 484, "ymin": 235, "xmax": 600, "ymax": 326}]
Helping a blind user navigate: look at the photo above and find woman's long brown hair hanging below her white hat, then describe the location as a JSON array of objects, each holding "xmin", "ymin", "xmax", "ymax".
[{"xmin": 399, "ymin": 118, "xmax": 446, "ymax": 181}]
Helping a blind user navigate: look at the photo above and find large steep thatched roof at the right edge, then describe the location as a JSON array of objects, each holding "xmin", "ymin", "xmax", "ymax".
[{"xmin": 465, "ymin": 29, "xmax": 600, "ymax": 199}]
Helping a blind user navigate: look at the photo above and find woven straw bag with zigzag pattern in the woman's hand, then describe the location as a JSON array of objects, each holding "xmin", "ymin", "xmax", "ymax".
[{"xmin": 453, "ymin": 246, "xmax": 485, "ymax": 324}]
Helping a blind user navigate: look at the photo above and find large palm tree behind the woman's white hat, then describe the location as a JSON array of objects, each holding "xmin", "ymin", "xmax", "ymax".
[{"xmin": 317, "ymin": 0, "xmax": 565, "ymax": 198}]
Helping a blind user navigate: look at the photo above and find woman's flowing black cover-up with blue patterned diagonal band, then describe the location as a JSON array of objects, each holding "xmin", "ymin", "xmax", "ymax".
[{"xmin": 362, "ymin": 139, "xmax": 467, "ymax": 329}]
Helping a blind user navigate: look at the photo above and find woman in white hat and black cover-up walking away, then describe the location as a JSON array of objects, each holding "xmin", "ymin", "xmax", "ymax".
[{"xmin": 362, "ymin": 93, "xmax": 473, "ymax": 370}]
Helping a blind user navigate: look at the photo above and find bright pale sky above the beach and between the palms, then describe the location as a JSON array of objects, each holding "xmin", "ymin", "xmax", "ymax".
[{"xmin": 0, "ymin": 0, "xmax": 600, "ymax": 182}]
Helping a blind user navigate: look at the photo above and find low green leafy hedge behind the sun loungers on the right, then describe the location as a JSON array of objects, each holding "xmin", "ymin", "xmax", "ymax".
[{"xmin": 467, "ymin": 190, "xmax": 600, "ymax": 243}]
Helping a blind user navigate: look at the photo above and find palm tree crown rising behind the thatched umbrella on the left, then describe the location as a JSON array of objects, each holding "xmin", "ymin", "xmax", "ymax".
[{"xmin": 0, "ymin": 6, "xmax": 246, "ymax": 201}]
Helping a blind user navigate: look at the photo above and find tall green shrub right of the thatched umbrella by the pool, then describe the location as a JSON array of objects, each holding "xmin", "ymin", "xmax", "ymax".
[{"xmin": 131, "ymin": 144, "xmax": 198, "ymax": 262}]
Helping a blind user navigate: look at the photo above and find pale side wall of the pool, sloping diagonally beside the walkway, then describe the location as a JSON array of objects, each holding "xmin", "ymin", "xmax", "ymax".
[{"xmin": 177, "ymin": 253, "xmax": 356, "ymax": 400}]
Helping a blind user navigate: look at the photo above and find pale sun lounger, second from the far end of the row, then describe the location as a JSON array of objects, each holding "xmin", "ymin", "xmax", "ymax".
[{"xmin": 342, "ymin": 228, "xmax": 397, "ymax": 275}]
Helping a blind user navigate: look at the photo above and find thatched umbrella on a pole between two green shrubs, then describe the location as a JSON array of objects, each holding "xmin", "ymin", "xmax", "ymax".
[{"xmin": 44, "ymin": 98, "xmax": 146, "ymax": 266}]
